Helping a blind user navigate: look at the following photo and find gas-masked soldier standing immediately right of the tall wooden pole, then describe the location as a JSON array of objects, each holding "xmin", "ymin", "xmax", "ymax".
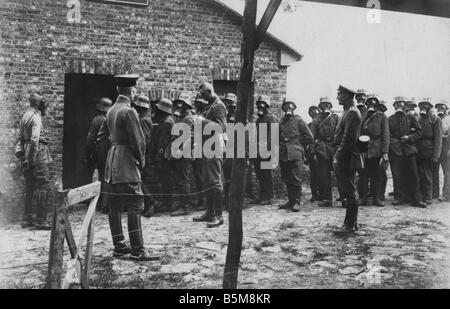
[{"xmin": 252, "ymin": 95, "xmax": 278, "ymax": 205}]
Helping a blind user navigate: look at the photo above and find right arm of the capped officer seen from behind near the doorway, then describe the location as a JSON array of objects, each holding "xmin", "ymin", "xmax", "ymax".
[{"xmin": 125, "ymin": 109, "xmax": 145, "ymax": 169}]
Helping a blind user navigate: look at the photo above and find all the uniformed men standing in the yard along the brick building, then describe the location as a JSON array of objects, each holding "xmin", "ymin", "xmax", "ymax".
[{"xmin": 16, "ymin": 75, "xmax": 450, "ymax": 260}]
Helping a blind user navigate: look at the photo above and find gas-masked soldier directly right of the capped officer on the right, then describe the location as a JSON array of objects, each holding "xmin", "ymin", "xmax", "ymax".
[{"xmin": 358, "ymin": 95, "xmax": 389, "ymax": 207}]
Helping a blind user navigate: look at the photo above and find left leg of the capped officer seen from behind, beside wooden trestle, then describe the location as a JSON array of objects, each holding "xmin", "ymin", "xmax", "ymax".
[{"xmin": 105, "ymin": 184, "xmax": 126, "ymax": 256}]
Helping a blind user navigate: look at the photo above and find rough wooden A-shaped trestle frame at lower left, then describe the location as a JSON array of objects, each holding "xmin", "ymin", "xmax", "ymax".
[{"xmin": 45, "ymin": 181, "xmax": 101, "ymax": 289}]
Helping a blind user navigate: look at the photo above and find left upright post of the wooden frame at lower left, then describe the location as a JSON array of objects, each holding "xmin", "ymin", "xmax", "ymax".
[{"xmin": 45, "ymin": 192, "xmax": 68, "ymax": 289}]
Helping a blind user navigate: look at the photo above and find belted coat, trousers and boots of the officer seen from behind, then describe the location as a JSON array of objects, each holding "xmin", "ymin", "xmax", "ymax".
[{"xmin": 104, "ymin": 95, "xmax": 146, "ymax": 256}]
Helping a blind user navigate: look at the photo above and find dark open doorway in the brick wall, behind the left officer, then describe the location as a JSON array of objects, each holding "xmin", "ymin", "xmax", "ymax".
[{"xmin": 63, "ymin": 74, "xmax": 117, "ymax": 189}]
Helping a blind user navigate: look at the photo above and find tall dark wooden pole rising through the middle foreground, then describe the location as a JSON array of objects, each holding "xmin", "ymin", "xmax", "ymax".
[{"xmin": 223, "ymin": 0, "xmax": 258, "ymax": 289}]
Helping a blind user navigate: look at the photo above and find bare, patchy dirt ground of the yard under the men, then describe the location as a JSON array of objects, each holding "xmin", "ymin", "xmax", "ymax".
[{"xmin": 0, "ymin": 190, "xmax": 450, "ymax": 289}]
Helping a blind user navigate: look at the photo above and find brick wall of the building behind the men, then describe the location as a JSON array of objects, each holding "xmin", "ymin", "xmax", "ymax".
[{"xmin": 0, "ymin": 0, "xmax": 287, "ymax": 223}]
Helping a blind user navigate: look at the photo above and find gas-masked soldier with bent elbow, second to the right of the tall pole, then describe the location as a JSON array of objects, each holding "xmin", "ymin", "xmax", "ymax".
[{"xmin": 279, "ymin": 98, "xmax": 314, "ymax": 212}]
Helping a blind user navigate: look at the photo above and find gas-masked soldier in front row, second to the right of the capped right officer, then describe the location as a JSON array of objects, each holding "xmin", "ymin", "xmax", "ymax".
[{"xmin": 388, "ymin": 97, "xmax": 426, "ymax": 207}]
